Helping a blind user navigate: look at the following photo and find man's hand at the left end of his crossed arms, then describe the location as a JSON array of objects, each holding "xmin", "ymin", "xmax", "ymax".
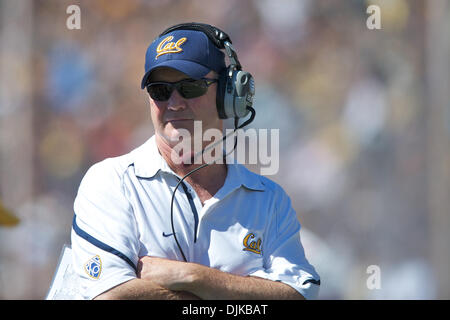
[{"xmin": 137, "ymin": 256, "xmax": 192, "ymax": 290}]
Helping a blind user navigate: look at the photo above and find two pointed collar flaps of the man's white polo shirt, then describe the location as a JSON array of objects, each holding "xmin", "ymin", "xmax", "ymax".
[{"xmin": 133, "ymin": 135, "xmax": 265, "ymax": 191}]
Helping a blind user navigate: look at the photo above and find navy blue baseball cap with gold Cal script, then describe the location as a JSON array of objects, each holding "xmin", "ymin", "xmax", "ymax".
[{"xmin": 141, "ymin": 30, "xmax": 226, "ymax": 89}]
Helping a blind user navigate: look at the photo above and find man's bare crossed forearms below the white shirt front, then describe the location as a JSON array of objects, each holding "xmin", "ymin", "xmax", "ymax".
[{"xmin": 95, "ymin": 257, "xmax": 304, "ymax": 300}]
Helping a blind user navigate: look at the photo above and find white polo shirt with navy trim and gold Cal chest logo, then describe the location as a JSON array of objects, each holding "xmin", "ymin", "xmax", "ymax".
[{"xmin": 71, "ymin": 136, "xmax": 320, "ymax": 299}]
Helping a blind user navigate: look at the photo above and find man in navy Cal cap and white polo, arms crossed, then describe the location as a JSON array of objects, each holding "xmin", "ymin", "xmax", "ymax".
[{"xmin": 72, "ymin": 23, "xmax": 320, "ymax": 299}]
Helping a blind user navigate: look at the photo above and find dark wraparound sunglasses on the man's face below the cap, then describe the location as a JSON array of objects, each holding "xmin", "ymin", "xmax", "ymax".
[{"xmin": 147, "ymin": 78, "xmax": 218, "ymax": 101}]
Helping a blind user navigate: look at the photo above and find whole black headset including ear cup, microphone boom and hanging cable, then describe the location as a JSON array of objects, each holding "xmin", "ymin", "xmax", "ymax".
[{"xmin": 159, "ymin": 22, "xmax": 256, "ymax": 261}]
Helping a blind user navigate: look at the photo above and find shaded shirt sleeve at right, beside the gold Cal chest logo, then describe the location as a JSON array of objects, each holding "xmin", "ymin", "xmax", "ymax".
[{"xmin": 251, "ymin": 186, "xmax": 320, "ymax": 299}]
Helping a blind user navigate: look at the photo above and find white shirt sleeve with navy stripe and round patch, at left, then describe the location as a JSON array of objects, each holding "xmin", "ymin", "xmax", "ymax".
[{"xmin": 71, "ymin": 160, "xmax": 139, "ymax": 299}]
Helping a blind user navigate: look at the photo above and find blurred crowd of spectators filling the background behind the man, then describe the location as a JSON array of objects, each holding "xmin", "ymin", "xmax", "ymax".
[{"xmin": 0, "ymin": 0, "xmax": 450, "ymax": 299}]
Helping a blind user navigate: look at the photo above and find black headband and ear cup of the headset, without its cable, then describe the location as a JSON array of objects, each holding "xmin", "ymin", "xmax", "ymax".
[{"xmin": 159, "ymin": 22, "xmax": 255, "ymax": 119}]
